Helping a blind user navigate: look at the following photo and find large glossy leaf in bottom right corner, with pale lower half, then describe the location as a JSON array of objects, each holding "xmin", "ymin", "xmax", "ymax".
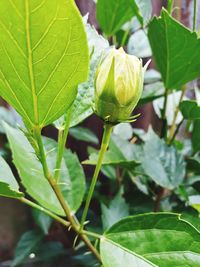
[{"xmin": 100, "ymin": 213, "xmax": 200, "ymax": 267}]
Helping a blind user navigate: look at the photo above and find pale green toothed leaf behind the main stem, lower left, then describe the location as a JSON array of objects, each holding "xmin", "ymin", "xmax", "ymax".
[{"xmin": 4, "ymin": 124, "xmax": 85, "ymax": 215}]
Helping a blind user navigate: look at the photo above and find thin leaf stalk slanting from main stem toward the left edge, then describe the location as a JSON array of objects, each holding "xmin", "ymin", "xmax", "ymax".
[{"xmin": 20, "ymin": 198, "xmax": 70, "ymax": 227}]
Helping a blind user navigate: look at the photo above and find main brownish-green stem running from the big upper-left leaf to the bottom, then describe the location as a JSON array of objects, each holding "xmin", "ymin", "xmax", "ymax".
[{"xmin": 35, "ymin": 128, "xmax": 101, "ymax": 262}]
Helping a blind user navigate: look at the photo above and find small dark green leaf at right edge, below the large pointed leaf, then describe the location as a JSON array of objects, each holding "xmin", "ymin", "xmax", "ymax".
[{"xmin": 180, "ymin": 100, "xmax": 200, "ymax": 120}]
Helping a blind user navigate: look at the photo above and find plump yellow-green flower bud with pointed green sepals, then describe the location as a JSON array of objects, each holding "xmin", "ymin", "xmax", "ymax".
[{"xmin": 95, "ymin": 48, "xmax": 144, "ymax": 123}]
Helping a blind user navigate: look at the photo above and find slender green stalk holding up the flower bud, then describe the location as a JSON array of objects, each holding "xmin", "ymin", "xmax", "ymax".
[{"xmin": 80, "ymin": 124, "xmax": 113, "ymax": 232}]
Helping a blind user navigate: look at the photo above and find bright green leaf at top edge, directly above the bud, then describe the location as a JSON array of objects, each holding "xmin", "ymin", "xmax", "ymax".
[{"xmin": 97, "ymin": 0, "xmax": 143, "ymax": 36}]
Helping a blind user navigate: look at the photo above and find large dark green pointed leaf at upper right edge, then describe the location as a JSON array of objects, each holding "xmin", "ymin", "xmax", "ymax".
[{"xmin": 148, "ymin": 9, "xmax": 200, "ymax": 89}]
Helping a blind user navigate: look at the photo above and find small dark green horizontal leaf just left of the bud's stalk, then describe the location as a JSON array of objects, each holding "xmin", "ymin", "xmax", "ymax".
[{"xmin": 69, "ymin": 127, "xmax": 99, "ymax": 145}]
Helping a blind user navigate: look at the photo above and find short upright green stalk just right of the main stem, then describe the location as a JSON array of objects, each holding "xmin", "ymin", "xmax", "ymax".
[{"xmin": 54, "ymin": 109, "xmax": 71, "ymax": 182}]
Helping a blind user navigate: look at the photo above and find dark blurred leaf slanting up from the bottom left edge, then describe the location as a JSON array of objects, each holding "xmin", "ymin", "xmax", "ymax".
[{"xmin": 11, "ymin": 231, "xmax": 44, "ymax": 267}]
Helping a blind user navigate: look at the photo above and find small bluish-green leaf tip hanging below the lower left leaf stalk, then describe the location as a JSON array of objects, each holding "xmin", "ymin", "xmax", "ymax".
[{"xmin": 32, "ymin": 209, "xmax": 53, "ymax": 235}]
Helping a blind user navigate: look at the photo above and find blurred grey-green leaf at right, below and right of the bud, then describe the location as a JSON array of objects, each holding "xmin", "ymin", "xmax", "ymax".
[{"xmin": 142, "ymin": 128, "xmax": 185, "ymax": 190}]
